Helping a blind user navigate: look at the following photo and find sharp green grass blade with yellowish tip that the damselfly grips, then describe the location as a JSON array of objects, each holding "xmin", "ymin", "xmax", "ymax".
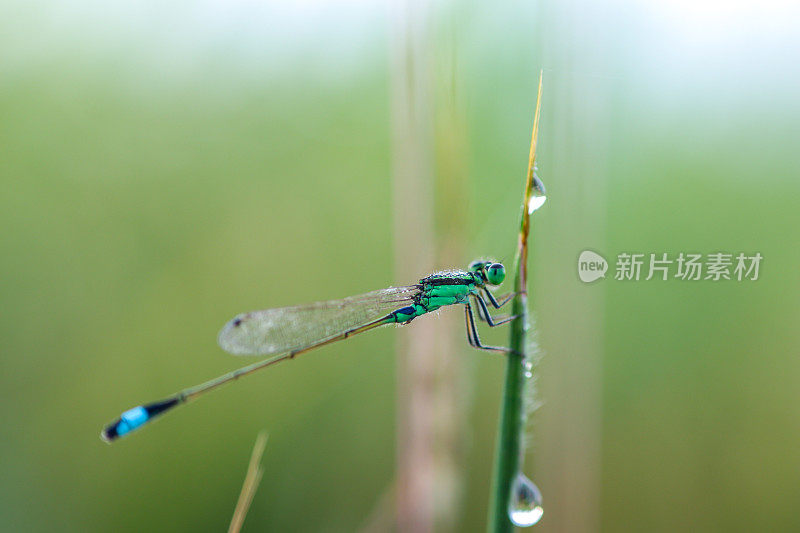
[{"xmin": 488, "ymin": 72, "xmax": 542, "ymax": 533}]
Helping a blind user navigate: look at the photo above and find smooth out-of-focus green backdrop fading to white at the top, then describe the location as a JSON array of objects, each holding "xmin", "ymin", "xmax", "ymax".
[{"xmin": 0, "ymin": 1, "xmax": 800, "ymax": 531}]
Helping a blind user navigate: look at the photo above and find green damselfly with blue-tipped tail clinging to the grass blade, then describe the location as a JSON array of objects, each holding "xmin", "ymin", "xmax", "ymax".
[{"xmin": 100, "ymin": 260, "xmax": 515, "ymax": 442}]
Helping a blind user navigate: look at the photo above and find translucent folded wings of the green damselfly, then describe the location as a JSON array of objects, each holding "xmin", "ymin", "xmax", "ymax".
[{"xmin": 217, "ymin": 285, "xmax": 419, "ymax": 355}]
